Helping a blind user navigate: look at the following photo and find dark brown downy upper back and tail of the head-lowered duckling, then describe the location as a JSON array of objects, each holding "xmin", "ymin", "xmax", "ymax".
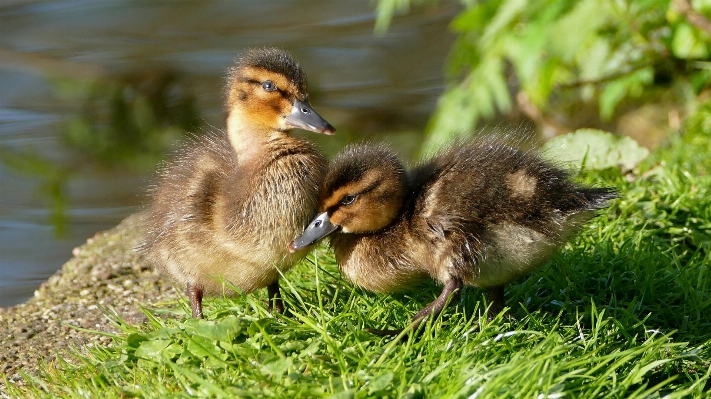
[{"xmin": 421, "ymin": 140, "xmax": 617, "ymax": 237}]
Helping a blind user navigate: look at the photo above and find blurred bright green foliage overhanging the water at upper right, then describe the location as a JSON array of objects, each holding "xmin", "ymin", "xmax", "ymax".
[{"xmin": 378, "ymin": 0, "xmax": 711, "ymax": 146}]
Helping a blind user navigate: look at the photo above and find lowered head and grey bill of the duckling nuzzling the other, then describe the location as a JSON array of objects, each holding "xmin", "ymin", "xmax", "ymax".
[{"xmin": 289, "ymin": 145, "xmax": 406, "ymax": 252}]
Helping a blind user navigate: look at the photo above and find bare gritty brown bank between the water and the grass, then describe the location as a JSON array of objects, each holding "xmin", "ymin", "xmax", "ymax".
[{"xmin": 0, "ymin": 214, "xmax": 178, "ymax": 397}]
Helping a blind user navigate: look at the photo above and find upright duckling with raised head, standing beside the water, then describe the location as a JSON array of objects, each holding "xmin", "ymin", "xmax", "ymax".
[{"xmin": 141, "ymin": 48, "xmax": 335, "ymax": 318}]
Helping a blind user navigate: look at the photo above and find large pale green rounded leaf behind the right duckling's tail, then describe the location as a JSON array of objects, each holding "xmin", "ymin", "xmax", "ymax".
[{"xmin": 543, "ymin": 129, "xmax": 649, "ymax": 170}]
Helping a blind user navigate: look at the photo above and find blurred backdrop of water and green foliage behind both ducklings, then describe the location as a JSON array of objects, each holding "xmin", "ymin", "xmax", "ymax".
[{"xmin": 0, "ymin": 0, "xmax": 711, "ymax": 306}]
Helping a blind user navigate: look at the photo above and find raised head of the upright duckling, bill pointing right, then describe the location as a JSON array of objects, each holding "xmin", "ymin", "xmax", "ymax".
[{"xmin": 226, "ymin": 48, "xmax": 336, "ymax": 143}]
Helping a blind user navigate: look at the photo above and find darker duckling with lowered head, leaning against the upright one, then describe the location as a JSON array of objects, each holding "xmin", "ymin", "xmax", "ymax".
[{"xmin": 289, "ymin": 137, "xmax": 617, "ymax": 335}]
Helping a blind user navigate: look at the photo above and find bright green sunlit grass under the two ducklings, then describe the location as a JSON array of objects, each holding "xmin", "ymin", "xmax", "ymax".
[{"xmin": 10, "ymin": 133, "xmax": 711, "ymax": 398}]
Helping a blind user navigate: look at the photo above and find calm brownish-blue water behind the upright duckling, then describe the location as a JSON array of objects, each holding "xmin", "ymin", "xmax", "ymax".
[{"xmin": 0, "ymin": 0, "xmax": 457, "ymax": 306}]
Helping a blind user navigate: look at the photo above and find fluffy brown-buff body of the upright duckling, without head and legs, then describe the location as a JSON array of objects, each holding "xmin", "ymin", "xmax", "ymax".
[{"xmin": 144, "ymin": 134, "xmax": 325, "ymax": 294}]
